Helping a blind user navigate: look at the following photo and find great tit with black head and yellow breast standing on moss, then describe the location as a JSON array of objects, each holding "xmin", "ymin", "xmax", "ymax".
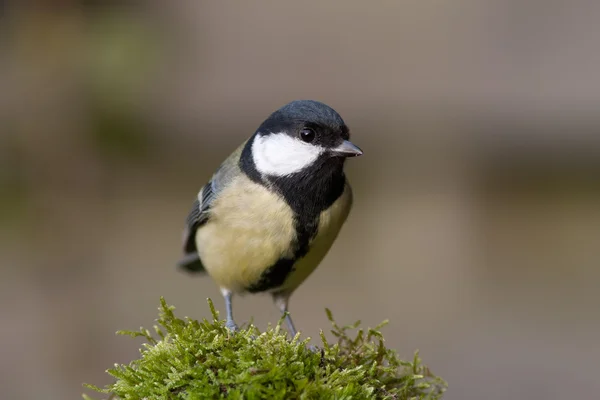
[{"xmin": 178, "ymin": 100, "xmax": 362, "ymax": 336}]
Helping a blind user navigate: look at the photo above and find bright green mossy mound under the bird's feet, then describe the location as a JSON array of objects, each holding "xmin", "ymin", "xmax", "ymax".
[{"xmin": 84, "ymin": 298, "xmax": 446, "ymax": 400}]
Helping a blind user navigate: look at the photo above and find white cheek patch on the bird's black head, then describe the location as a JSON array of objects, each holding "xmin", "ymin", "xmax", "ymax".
[{"xmin": 252, "ymin": 133, "xmax": 325, "ymax": 176}]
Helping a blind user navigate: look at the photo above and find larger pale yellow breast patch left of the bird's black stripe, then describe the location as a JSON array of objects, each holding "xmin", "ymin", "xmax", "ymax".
[{"xmin": 196, "ymin": 174, "xmax": 296, "ymax": 292}]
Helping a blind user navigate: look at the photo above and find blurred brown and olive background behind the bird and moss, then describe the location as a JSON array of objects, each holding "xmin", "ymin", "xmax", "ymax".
[{"xmin": 0, "ymin": 0, "xmax": 600, "ymax": 400}]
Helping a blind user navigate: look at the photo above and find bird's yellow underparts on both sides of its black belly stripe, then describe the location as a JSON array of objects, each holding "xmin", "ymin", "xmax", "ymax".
[{"xmin": 196, "ymin": 174, "xmax": 352, "ymax": 293}]
